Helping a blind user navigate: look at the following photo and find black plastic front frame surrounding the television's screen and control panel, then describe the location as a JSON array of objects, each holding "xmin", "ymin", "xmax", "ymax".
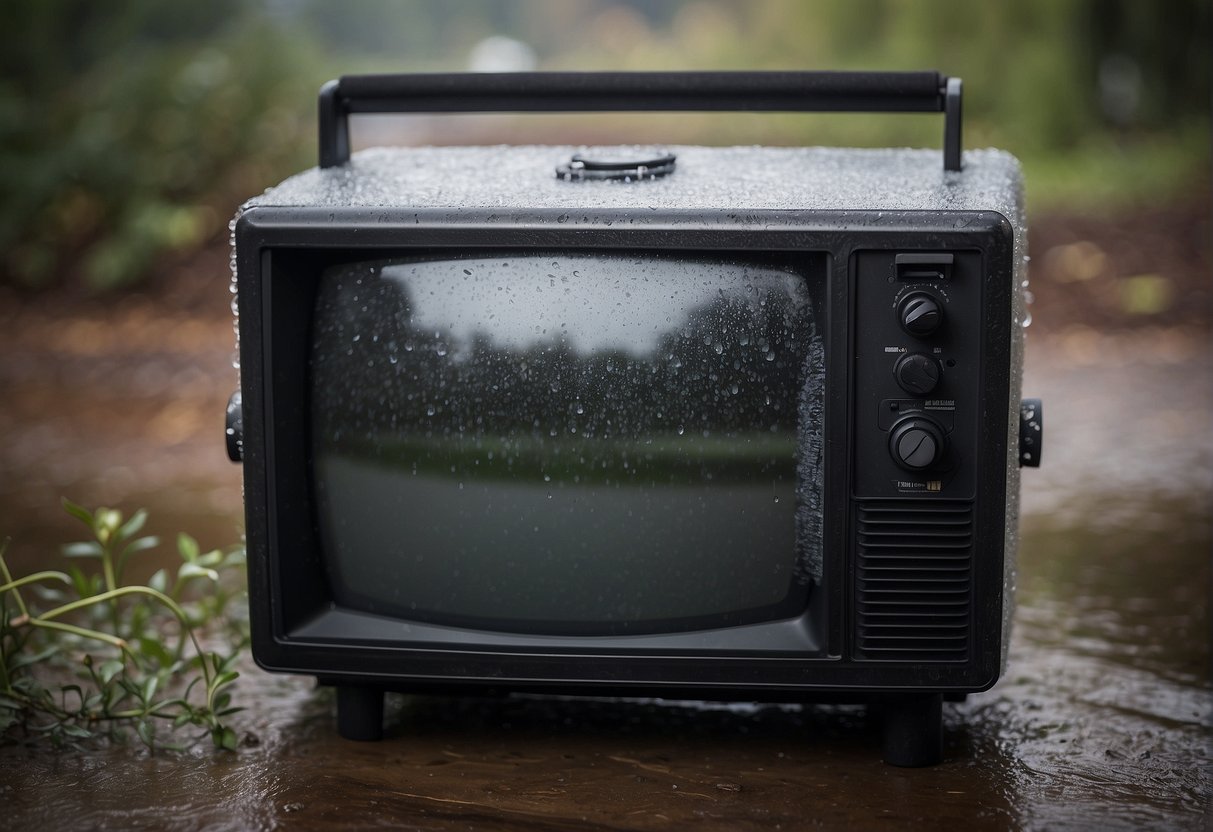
[{"xmin": 237, "ymin": 207, "xmax": 1013, "ymax": 699}]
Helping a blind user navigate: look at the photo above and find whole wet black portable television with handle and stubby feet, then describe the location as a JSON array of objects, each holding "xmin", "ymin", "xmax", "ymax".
[{"xmin": 228, "ymin": 73, "xmax": 1040, "ymax": 765}]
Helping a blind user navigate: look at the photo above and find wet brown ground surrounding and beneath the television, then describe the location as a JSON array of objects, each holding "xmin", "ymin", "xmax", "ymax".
[{"xmin": 0, "ymin": 208, "xmax": 1213, "ymax": 830}]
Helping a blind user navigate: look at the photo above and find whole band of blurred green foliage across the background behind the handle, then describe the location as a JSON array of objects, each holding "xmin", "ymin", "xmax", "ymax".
[{"xmin": 0, "ymin": 0, "xmax": 1211, "ymax": 293}]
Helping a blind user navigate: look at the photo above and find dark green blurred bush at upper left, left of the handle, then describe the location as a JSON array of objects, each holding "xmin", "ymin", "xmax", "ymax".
[{"xmin": 0, "ymin": 0, "xmax": 315, "ymax": 289}]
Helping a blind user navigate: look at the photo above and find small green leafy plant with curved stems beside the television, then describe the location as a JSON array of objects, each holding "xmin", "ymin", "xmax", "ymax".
[{"xmin": 0, "ymin": 500, "xmax": 247, "ymax": 750}]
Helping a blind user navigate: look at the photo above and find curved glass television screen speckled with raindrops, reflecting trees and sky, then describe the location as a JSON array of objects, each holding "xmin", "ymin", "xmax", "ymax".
[{"xmin": 309, "ymin": 251, "xmax": 826, "ymax": 636}]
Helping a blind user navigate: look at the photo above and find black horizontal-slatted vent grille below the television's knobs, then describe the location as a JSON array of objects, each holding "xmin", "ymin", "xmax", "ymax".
[{"xmin": 855, "ymin": 500, "xmax": 973, "ymax": 661}]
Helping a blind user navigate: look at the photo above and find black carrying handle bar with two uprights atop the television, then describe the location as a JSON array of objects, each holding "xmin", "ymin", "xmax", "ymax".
[{"xmin": 320, "ymin": 72, "xmax": 961, "ymax": 171}]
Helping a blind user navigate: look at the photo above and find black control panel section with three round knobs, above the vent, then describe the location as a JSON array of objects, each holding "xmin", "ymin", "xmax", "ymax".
[{"xmin": 850, "ymin": 246, "xmax": 984, "ymax": 500}]
